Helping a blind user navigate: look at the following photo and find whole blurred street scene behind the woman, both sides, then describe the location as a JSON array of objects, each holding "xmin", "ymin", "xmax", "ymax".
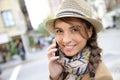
[{"xmin": 0, "ymin": 0, "xmax": 120, "ymax": 80}]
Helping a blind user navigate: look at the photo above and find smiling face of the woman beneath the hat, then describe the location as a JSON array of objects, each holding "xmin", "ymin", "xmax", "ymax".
[{"xmin": 55, "ymin": 18, "xmax": 93, "ymax": 56}]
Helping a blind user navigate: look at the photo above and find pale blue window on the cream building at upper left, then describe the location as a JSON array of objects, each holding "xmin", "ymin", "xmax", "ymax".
[{"xmin": 1, "ymin": 10, "xmax": 15, "ymax": 27}]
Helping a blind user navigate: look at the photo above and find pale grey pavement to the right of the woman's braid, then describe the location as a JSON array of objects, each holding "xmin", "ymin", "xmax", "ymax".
[{"xmin": 99, "ymin": 28, "xmax": 120, "ymax": 80}]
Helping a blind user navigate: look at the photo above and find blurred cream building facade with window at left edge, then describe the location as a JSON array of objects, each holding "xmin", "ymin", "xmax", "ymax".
[{"xmin": 0, "ymin": 0, "xmax": 32, "ymax": 61}]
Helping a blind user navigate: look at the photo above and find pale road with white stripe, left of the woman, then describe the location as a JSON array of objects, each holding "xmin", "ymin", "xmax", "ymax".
[{"xmin": 2, "ymin": 54, "xmax": 48, "ymax": 80}]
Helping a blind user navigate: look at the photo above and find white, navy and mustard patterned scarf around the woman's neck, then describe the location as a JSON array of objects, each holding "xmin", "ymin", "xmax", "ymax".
[{"xmin": 58, "ymin": 48, "xmax": 90, "ymax": 80}]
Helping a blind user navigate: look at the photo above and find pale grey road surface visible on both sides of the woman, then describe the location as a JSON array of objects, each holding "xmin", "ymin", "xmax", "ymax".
[{"xmin": 2, "ymin": 29, "xmax": 120, "ymax": 80}]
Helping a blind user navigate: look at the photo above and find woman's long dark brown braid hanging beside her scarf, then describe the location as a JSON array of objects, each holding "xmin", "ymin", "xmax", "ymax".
[{"xmin": 83, "ymin": 20, "xmax": 102, "ymax": 80}]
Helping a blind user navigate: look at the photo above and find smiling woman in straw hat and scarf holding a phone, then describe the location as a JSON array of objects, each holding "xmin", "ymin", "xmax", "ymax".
[{"xmin": 46, "ymin": 0, "xmax": 112, "ymax": 80}]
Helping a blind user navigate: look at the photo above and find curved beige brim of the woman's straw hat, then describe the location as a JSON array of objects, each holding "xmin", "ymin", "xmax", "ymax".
[{"xmin": 46, "ymin": 15, "xmax": 103, "ymax": 34}]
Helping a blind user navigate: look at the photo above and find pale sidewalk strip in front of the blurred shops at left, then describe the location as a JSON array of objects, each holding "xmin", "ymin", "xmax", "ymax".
[{"xmin": 0, "ymin": 46, "xmax": 47, "ymax": 70}]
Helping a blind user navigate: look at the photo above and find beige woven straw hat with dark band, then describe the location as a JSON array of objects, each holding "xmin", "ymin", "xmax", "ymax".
[{"xmin": 46, "ymin": 0, "xmax": 103, "ymax": 33}]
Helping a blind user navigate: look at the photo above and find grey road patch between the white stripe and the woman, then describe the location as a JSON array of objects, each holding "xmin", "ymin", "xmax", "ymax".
[{"xmin": 16, "ymin": 57, "xmax": 48, "ymax": 80}]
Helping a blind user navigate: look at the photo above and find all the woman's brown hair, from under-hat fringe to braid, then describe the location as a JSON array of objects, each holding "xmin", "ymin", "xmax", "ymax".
[{"xmin": 54, "ymin": 17, "xmax": 102, "ymax": 80}]
